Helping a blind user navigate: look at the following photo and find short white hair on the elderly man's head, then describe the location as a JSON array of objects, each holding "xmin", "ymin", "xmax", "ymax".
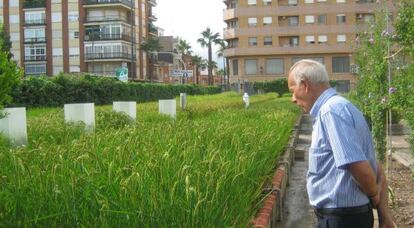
[{"xmin": 288, "ymin": 59, "xmax": 329, "ymax": 85}]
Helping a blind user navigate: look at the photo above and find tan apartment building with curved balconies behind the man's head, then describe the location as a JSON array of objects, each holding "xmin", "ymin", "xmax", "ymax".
[{"xmin": 223, "ymin": 0, "xmax": 395, "ymax": 91}]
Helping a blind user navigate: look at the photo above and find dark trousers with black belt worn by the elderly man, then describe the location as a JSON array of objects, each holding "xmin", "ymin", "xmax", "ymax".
[{"xmin": 315, "ymin": 206, "xmax": 374, "ymax": 228}]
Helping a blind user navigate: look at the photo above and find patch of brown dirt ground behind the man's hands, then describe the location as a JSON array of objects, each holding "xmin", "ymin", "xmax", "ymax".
[{"xmin": 389, "ymin": 161, "xmax": 414, "ymax": 227}]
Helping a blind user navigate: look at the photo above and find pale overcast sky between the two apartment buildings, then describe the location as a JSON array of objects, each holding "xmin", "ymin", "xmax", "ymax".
[{"xmin": 153, "ymin": 0, "xmax": 226, "ymax": 67}]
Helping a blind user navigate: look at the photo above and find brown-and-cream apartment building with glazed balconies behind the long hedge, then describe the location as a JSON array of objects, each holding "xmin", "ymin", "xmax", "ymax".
[{"xmin": 0, "ymin": 0, "xmax": 157, "ymax": 79}]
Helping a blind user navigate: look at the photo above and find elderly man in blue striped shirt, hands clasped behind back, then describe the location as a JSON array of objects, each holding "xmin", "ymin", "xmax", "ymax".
[{"xmin": 288, "ymin": 60, "xmax": 392, "ymax": 228}]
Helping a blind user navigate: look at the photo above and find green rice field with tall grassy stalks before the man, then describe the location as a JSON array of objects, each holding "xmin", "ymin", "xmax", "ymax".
[{"xmin": 0, "ymin": 93, "xmax": 299, "ymax": 227}]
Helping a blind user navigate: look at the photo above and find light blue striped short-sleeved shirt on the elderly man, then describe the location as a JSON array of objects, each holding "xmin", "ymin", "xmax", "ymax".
[{"xmin": 307, "ymin": 88, "xmax": 377, "ymax": 208}]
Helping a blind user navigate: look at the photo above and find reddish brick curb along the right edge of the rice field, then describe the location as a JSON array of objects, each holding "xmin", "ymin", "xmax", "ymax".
[{"xmin": 251, "ymin": 114, "xmax": 303, "ymax": 228}]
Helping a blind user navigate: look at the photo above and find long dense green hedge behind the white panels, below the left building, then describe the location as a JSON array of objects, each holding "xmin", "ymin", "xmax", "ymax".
[{"xmin": 12, "ymin": 75, "xmax": 221, "ymax": 107}]
